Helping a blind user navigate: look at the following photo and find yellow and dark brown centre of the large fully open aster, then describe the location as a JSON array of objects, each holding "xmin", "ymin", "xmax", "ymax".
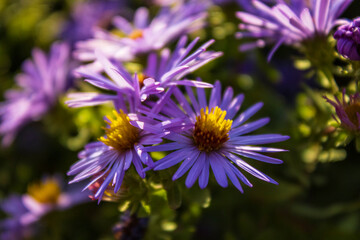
[{"xmin": 193, "ymin": 107, "xmax": 232, "ymax": 152}]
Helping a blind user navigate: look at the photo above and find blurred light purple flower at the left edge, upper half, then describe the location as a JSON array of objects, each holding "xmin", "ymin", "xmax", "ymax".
[{"xmin": 0, "ymin": 43, "xmax": 70, "ymax": 146}]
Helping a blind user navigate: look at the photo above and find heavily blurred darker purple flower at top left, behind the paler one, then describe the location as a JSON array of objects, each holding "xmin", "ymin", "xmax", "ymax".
[{"xmin": 62, "ymin": 0, "xmax": 123, "ymax": 43}]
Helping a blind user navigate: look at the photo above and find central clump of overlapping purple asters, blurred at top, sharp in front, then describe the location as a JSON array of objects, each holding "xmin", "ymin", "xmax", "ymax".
[{"xmin": 66, "ymin": 1, "xmax": 288, "ymax": 202}]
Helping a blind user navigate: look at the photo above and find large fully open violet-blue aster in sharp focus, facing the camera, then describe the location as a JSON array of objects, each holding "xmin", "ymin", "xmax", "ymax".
[{"xmin": 141, "ymin": 81, "xmax": 289, "ymax": 192}]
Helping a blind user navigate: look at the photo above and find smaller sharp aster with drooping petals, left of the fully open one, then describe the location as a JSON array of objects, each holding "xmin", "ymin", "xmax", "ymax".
[{"xmin": 68, "ymin": 110, "xmax": 162, "ymax": 203}]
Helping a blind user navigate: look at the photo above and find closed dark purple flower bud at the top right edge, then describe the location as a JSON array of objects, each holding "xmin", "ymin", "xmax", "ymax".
[{"xmin": 334, "ymin": 17, "xmax": 360, "ymax": 61}]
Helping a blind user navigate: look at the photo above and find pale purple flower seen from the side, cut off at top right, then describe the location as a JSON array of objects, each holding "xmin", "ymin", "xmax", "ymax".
[{"xmin": 236, "ymin": 0, "xmax": 352, "ymax": 58}]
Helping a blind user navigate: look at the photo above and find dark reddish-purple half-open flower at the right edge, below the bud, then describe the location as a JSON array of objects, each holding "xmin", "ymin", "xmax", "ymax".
[{"xmin": 324, "ymin": 89, "xmax": 360, "ymax": 134}]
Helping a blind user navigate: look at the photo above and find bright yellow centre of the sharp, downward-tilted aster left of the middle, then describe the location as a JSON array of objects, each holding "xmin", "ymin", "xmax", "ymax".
[{"xmin": 99, "ymin": 110, "xmax": 139, "ymax": 152}]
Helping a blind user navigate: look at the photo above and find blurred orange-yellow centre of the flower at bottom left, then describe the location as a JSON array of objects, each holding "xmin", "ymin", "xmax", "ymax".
[{"xmin": 28, "ymin": 178, "xmax": 61, "ymax": 204}]
